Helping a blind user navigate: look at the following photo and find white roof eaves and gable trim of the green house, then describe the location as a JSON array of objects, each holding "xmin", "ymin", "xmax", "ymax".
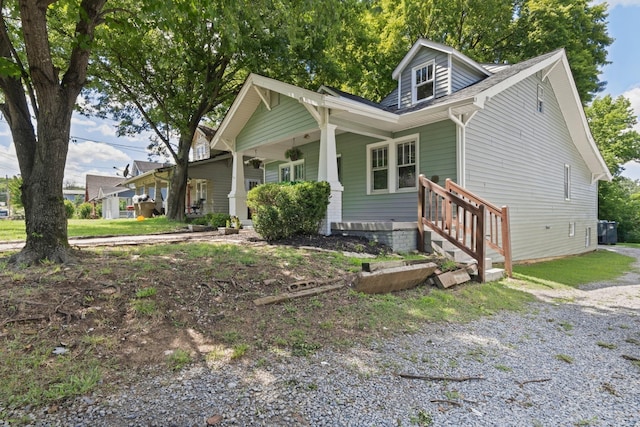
[{"xmin": 211, "ymin": 43, "xmax": 612, "ymax": 181}]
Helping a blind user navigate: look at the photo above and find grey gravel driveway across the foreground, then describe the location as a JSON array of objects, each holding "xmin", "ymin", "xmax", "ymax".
[{"xmin": 5, "ymin": 248, "xmax": 640, "ymax": 427}]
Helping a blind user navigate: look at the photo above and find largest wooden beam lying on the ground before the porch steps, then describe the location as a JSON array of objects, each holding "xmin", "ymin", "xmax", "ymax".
[{"xmin": 355, "ymin": 262, "xmax": 438, "ymax": 294}]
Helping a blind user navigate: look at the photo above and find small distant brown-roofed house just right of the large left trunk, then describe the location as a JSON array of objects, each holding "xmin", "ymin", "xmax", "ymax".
[{"xmin": 84, "ymin": 175, "xmax": 134, "ymax": 219}]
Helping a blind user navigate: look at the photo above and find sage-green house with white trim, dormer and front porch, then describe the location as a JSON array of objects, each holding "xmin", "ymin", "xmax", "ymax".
[{"xmin": 212, "ymin": 39, "xmax": 611, "ymax": 260}]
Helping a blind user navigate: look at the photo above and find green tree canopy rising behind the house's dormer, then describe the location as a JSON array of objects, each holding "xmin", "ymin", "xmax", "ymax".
[{"xmin": 336, "ymin": 0, "xmax": 613, "ymax": 104}]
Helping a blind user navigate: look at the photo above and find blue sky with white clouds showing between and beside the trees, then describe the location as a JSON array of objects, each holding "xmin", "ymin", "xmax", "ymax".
[{"xmin": 0, "ymin": 0, "xmax": 640, "ymax": 186}]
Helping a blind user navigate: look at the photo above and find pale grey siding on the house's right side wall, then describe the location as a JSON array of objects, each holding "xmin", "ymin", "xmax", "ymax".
[{"xmin": 466, "ymin": 76, "xmax": 597, "ymax": 260}]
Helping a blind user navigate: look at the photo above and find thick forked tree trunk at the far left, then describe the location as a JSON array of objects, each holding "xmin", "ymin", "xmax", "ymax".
[{"xmin": 0, "ymin": 0, "xmax": 106, "ymax": 265}]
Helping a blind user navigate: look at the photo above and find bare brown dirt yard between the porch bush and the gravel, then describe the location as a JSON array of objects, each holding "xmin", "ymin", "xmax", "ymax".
[{"xmin": 0, "ymin": 232, "xmax": 420, "ymax": 390}]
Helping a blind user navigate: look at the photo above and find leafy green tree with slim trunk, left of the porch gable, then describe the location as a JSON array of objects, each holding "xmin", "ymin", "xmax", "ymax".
[{"xmin": 85, "ymin": 0, "xmax": 358, "ymax": 219}]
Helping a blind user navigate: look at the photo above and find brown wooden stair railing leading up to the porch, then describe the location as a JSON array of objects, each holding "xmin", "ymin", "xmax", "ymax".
[{"xmin": 418, "ymin": 175, "xmax": 512, "ymax": 282}]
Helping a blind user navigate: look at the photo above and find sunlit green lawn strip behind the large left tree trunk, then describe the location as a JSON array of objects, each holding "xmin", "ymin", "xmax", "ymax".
[{"xmin": 0, "ymin": 217, "xmax": 185, "ymax": 241}]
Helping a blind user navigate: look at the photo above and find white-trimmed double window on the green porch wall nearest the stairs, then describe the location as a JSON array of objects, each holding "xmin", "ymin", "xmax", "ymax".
[{"xmin": 367, "ymin": 135, "xmax": 418, "ymax": 194}]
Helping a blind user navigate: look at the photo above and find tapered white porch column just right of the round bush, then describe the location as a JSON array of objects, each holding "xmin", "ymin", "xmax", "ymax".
[{"xmin": 318, "ymin": 120, "xmax": 344, "ymax": 236}]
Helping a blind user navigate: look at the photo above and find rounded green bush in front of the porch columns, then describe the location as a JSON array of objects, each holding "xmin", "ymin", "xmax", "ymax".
[{"xmin": 247, "ymin": 181, "xmax": 331, "ymax": 240}]
